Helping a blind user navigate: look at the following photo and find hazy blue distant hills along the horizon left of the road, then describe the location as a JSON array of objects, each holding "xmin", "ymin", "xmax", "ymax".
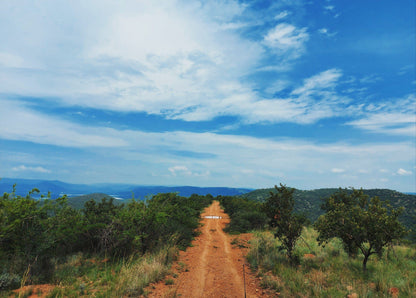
[{"xmin": 0, "ymin": 178, "xmax": 252, "ymax": 200}]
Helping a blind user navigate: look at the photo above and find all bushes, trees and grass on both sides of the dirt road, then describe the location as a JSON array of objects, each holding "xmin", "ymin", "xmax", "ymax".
[{"xmin": 0, "ymin": 185, "xmax": 416, "ymax": 297}]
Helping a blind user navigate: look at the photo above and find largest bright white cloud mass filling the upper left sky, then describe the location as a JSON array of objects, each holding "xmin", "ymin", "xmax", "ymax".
[{"xmin": 0, "ymin": 0, "xmax": 264, "ymax": 120}]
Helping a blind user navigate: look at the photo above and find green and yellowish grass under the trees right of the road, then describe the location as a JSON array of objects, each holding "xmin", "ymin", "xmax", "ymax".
[{"xmin": 247, "ymin": 228, "xmax": 416, "ymax": 297}]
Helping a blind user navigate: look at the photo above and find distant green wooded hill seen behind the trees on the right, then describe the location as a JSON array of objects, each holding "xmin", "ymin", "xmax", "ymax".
[{"xmin": 240, "ymin": 188, "xmax": 416, "ymax": 228}]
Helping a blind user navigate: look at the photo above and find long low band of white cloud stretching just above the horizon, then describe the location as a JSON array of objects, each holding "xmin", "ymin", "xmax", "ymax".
[{"xmin": 0, "ymin": 101, "xmax": 414, "ymax": 188}]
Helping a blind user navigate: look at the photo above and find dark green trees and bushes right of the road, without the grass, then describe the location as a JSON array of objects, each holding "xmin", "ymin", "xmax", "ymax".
[{"xmin": 220, "ymin": 184, "xmax": 407, "ymax": 271}]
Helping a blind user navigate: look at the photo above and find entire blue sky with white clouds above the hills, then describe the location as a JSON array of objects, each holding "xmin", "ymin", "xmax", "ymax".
[{"xmin": 0, "ymin": 0, "xmax": 416, "ymax": 191}]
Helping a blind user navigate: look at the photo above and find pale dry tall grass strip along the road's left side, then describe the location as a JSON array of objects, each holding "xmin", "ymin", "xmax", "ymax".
[{"xmin": 29, "ymin": 246, "xmax": 178, "ymax": 297}]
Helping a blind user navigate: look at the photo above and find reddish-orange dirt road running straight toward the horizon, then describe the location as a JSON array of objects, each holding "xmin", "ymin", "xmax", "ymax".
[{"xmin": 145, "ymin": 201, "xmax": 268, "ymax": 297}]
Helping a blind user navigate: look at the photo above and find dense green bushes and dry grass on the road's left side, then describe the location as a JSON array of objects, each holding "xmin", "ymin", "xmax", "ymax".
[{"xmin": 0, "ymin": 188, "xmax": 213, "ymax": 297}]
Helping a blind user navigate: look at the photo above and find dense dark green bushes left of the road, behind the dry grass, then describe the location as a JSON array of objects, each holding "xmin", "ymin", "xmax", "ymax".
[{"xmin": 0, "ymin": 188, "xmax": 213, "ymax": 288}]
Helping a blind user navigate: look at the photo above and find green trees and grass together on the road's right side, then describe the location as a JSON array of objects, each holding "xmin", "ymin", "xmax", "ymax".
[{"xmin": 221, "ymin": 185, "xmax": 416, "ymax": 297}]
